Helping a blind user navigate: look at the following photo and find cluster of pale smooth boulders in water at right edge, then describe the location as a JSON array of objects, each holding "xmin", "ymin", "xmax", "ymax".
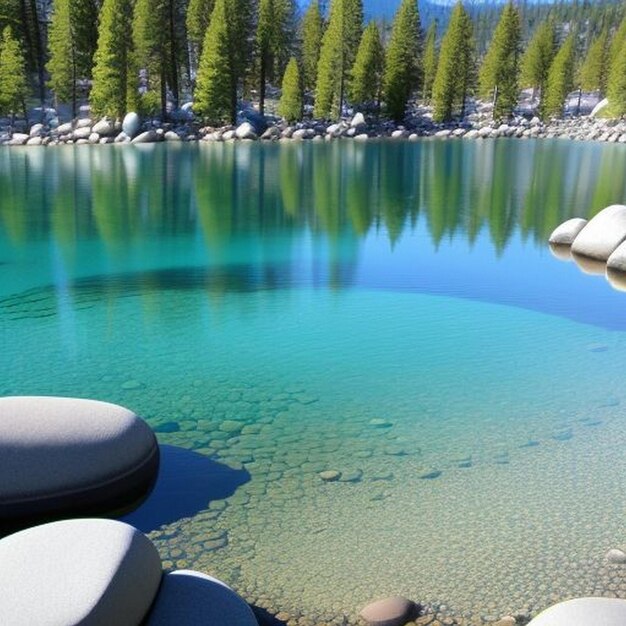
[{"xmin": 549, "ymin": 204, "xmax": 626, "ymax": 290}]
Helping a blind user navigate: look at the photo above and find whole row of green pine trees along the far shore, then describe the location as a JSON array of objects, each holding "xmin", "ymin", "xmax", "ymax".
[{"xmin": 0, "ymin": 0, "xmax": 626, "ymax": 125}]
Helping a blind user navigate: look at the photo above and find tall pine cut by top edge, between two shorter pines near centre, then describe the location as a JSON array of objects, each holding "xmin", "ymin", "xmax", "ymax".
[{"xmin": 315, "ymin": 0, "xmax": 363, "ymax": 118}]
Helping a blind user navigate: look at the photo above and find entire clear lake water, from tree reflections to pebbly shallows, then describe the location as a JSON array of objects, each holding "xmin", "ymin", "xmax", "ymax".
[{"xmin": 0, "ymin": 141, "xmax": 626, "ymax": 623}]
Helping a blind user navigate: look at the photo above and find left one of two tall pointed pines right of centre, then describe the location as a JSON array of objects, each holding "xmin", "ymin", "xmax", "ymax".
[{"xmin": 433, "ymin": 2, "xmax": 476, "ymax": 122}]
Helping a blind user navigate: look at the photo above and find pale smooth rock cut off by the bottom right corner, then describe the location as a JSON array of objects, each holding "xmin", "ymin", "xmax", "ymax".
[{"xmin": 529, "ymin": 598, "xmax": 626, "ymax": 626}]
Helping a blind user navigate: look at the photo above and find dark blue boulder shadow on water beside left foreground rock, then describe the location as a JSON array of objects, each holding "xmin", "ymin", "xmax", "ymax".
[{"xmin": 120, "ymin": 445, "xmax": 250, "ymax": 532}]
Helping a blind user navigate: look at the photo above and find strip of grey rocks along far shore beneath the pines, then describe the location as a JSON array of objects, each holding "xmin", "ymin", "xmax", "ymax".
[{"xmin": 0, "ymin": 107, "xmax": 626, "ymax": 146}]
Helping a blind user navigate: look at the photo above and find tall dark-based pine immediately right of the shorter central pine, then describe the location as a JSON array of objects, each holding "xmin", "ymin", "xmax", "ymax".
[{"xmin": 383, "ymin": 0, "xmax": 421, "ymax": 122}]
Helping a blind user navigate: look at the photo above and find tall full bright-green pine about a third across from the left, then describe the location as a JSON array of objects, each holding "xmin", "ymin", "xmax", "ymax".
[{"xmin": 194, "ymin": 0, "xmax": 233, "ymax": 124}]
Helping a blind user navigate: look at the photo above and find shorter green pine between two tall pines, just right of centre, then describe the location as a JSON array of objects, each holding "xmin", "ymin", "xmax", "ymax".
[{"xmin": 350, "ymin": 22, "xmax": 385, "ymax": 104}]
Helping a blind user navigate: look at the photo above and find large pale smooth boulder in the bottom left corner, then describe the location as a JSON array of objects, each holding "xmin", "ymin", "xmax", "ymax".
[{"xmin": 0, "ymin": 519, "xmax": 162, "ymax": 626}]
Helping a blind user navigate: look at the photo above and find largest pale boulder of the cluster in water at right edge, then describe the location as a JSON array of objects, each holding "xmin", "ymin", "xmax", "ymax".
[{"xmin": 572, "ymin": 204, "xmax": 626, "ymax": 261}]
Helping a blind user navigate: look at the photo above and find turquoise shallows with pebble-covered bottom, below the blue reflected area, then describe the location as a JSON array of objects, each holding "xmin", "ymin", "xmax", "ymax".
[{"xmin": 0, "ymin": 281, "xmax": 626, "ymax": 626}]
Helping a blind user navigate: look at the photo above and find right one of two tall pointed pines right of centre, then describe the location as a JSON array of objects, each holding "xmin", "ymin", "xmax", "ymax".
[{"xmin": 480, "ymin": 1, "xmax": 521, "ymax": 119}]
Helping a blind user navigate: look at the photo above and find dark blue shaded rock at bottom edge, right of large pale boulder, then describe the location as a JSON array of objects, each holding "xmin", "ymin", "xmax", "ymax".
[{"xmin": 145, "ymin": 570, "xmax": 258, "ymax": 626}]
